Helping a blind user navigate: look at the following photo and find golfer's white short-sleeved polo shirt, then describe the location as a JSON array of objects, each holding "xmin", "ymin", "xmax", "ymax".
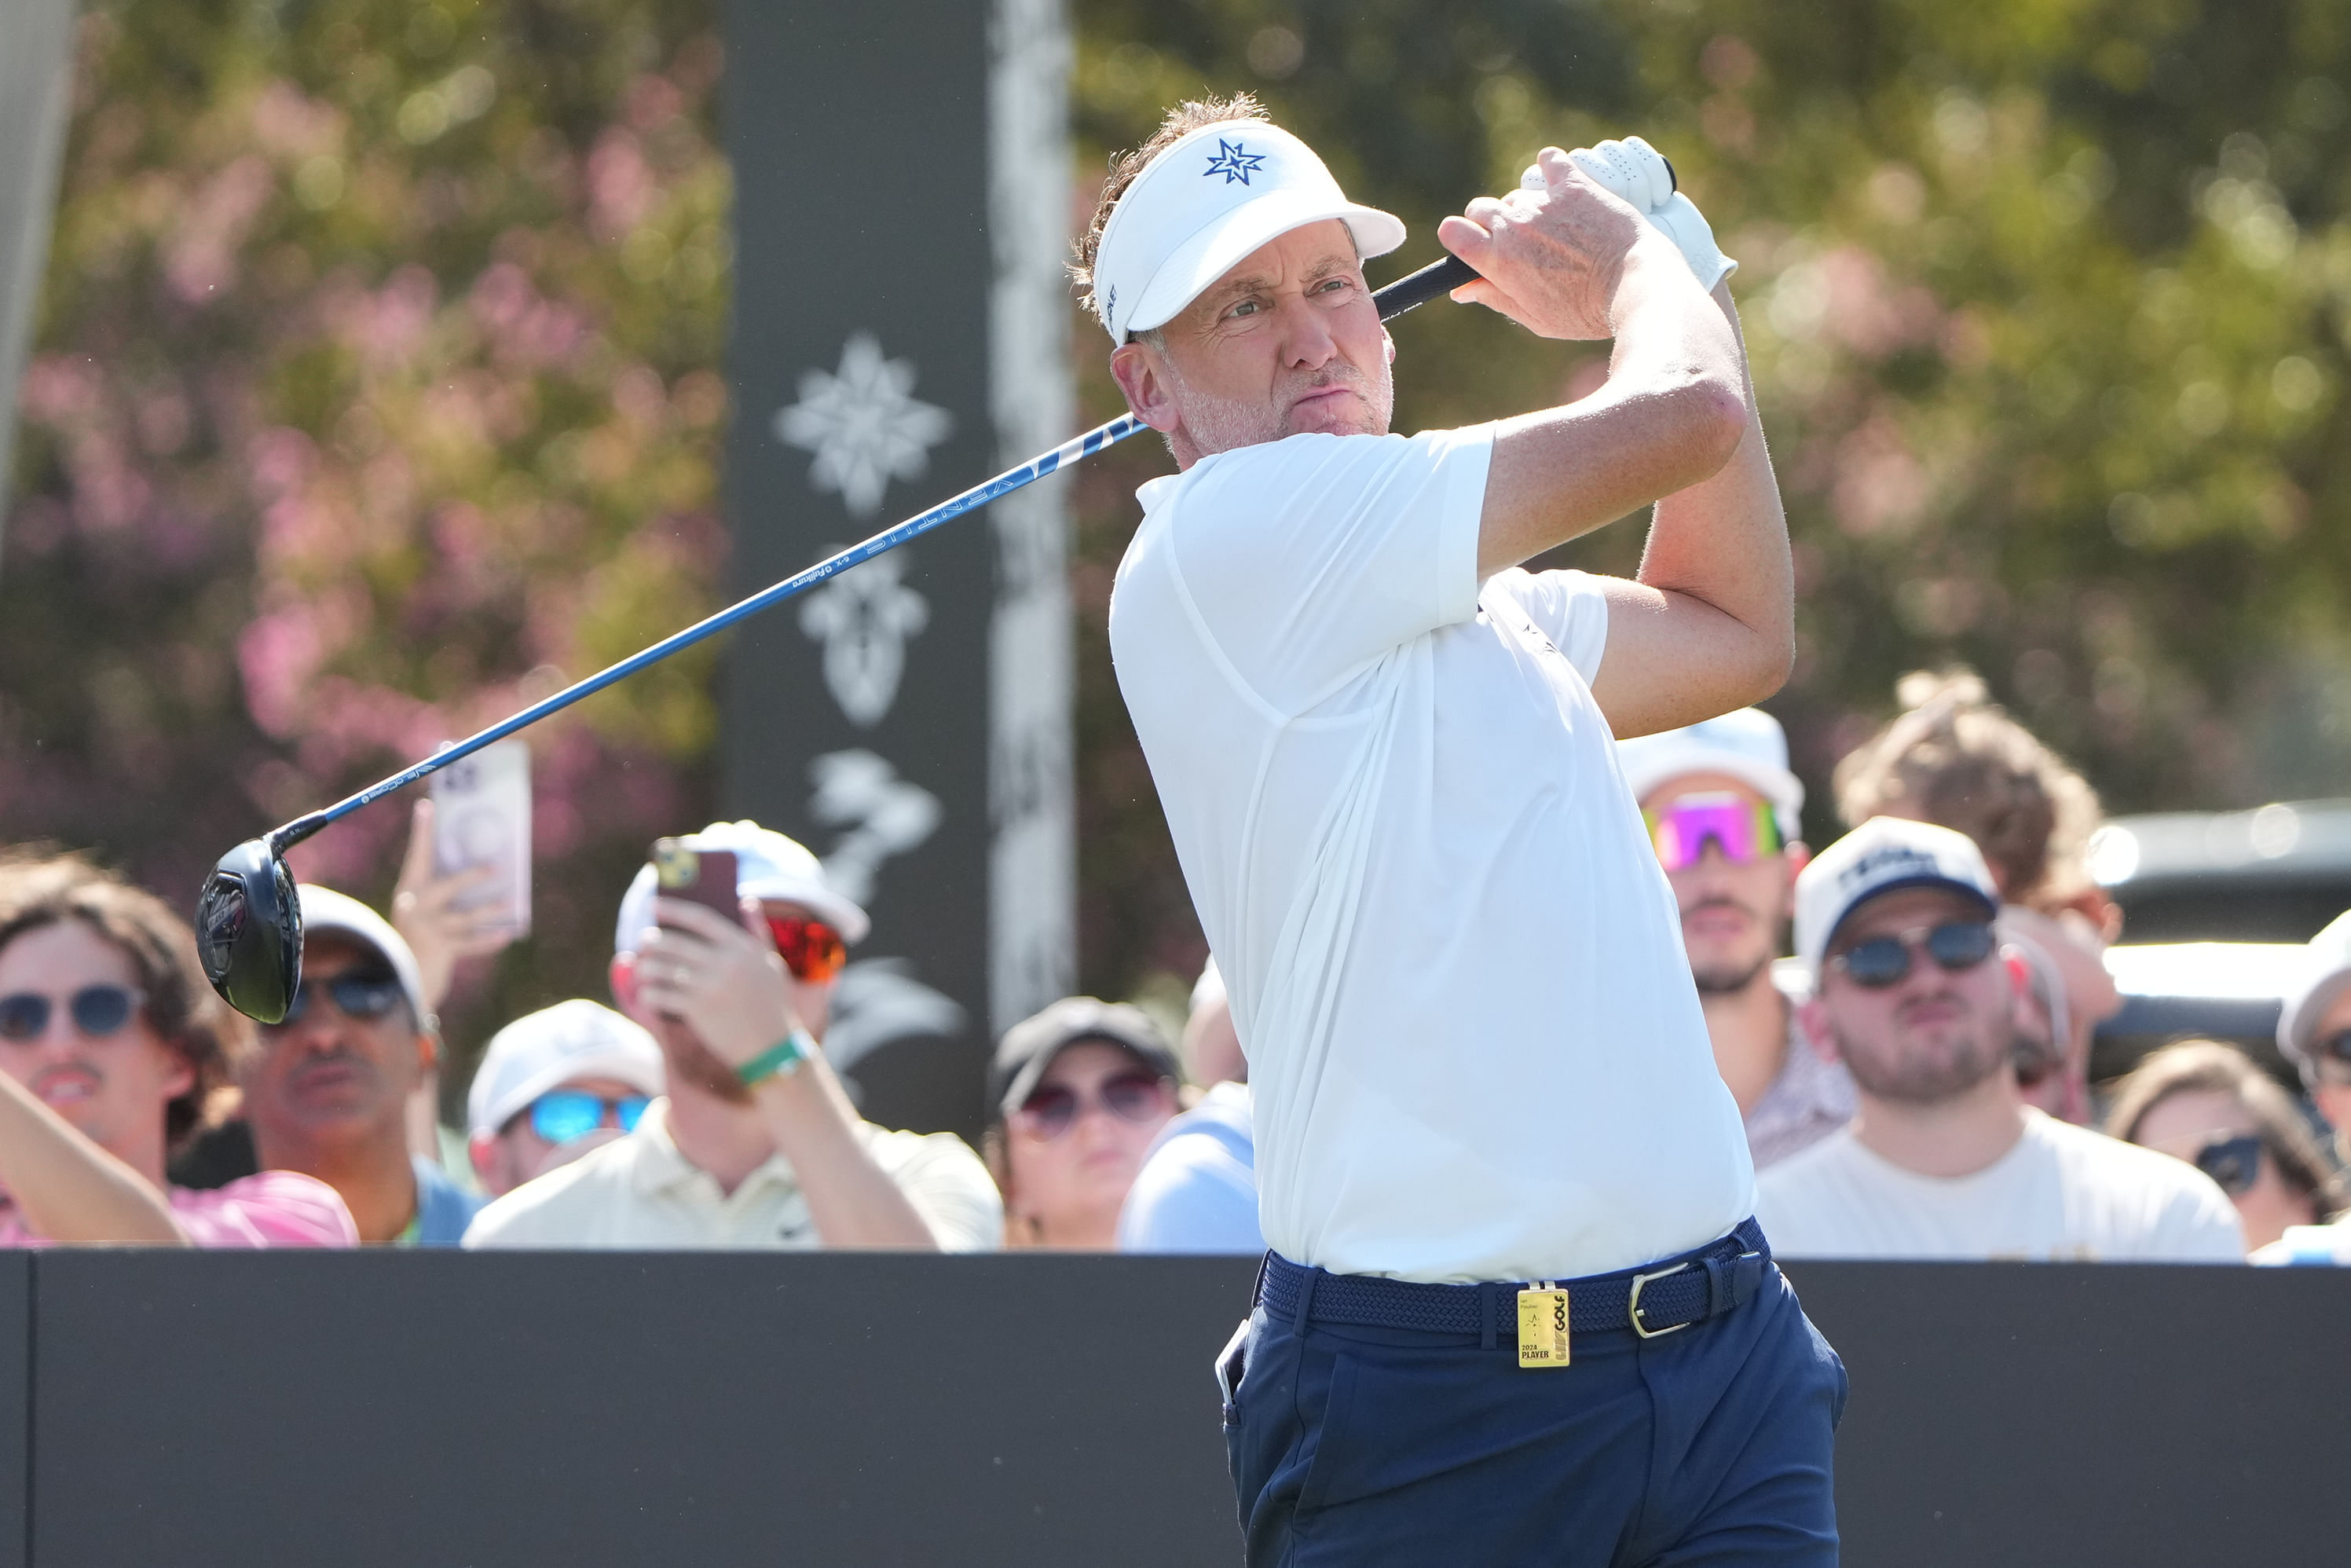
[{"xmin": 1110, "ymin": 428, "xmax": 1754, "ymax": 1281}]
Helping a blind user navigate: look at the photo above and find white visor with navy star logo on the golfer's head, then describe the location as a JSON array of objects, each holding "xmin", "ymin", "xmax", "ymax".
[{"xmin": 1093, "ymin": 120, "xmax": 1404, "ymax": 343}]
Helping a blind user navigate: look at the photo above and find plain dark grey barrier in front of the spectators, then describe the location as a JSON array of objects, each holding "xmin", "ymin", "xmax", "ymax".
[{"xmin": 0, "ymin": 1253, "xmax": 2351, "ymax": 1568}]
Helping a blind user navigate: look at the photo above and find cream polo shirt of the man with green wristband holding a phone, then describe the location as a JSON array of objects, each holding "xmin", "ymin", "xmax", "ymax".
[{"xmin": 466, "ymin": 1100, "xmax": 1004, "ymax": 1253}]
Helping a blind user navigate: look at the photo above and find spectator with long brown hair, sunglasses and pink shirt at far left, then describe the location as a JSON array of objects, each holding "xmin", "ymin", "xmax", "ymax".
[{"xmin": 0, "ymin": 855, "xmax": 357, "ymax": 1248}]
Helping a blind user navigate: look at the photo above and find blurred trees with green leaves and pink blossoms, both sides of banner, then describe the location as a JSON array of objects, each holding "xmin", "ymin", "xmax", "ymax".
[{"xmin": 0, "ymin": 0, "xmax": 2351, "ymax": 1044}]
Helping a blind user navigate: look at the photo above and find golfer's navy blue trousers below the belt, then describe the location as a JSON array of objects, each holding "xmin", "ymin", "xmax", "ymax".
[{"xmin": 1220, "ymin": 1241, "xmax": 1846, "ymax": 1568}]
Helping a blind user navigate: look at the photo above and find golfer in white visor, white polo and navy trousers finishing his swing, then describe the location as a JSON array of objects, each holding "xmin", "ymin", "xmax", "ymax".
[{"xmin": 1079, "ymin": 101, "xmax": 1846, "ymax": 1568}]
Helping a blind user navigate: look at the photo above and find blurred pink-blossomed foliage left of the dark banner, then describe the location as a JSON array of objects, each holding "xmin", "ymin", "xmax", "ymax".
[{"xmin": 0, "ymin": 0, "xmax": 729, "ymax": 1072}]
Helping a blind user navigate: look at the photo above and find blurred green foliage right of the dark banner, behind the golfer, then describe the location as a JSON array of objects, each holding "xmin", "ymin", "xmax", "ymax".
[{"xmin": 1077, "ymin": 0, "xmax": 2351, "ymax": 990}]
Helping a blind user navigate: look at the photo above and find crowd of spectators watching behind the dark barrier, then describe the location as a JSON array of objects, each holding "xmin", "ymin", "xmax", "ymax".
[{"xmin": 0, "ymin": 672, "xmax": 2351, "ymax": 1262}]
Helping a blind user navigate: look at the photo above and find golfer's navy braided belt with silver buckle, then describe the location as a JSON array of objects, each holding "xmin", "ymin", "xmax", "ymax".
[{"xmin": 1258, "ymin": 1220, "xmax": 1771, "ymax": 1345}]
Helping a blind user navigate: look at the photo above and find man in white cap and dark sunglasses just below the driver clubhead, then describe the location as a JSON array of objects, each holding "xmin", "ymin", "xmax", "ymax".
[{"xmin": 237, "ymin": 884, "xmax": 482, "ymax": 1246}]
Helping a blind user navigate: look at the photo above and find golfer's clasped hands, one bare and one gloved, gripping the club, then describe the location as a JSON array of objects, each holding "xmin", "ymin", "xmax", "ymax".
[{"xmin": 1437, "ymin": 148, "xmax": 1681, "ymax": 339}]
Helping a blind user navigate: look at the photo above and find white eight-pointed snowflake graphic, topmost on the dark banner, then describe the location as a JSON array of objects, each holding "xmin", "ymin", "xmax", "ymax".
[{"xmin": 776, "ymin": 332, "xmax": 954, "ymax": 517}]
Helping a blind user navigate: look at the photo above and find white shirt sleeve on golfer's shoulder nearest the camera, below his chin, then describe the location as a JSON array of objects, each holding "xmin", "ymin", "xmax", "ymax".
[{"xmin": 1174, "ymin": 426, "xmax": 1493, "ymax": 713}]
